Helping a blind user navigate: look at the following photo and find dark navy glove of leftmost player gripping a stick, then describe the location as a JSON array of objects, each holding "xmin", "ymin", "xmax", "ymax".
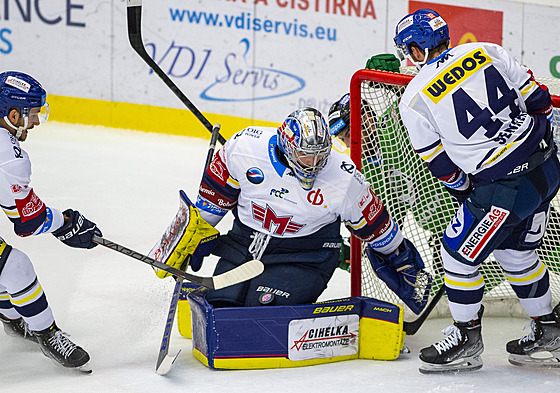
[{"xmin": 53, "ymin": 209, "xmax": 103, "ymax": 248}]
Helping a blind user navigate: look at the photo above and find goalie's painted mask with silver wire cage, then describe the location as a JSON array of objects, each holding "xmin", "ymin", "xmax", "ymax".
[{"xmin": 277, "ymin": 108, "xmax": 331, "ymax": 190}]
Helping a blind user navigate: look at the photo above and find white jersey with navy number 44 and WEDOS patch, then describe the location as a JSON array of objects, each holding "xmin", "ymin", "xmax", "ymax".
[{"xmin": 399, "ymin": 43, "xmax": 550, "ymax": 183}]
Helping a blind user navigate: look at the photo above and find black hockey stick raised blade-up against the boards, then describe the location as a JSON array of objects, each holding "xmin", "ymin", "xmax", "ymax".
[{"xmin": 126, "ymin": 0, "xmax": 226, "ymax": 145}]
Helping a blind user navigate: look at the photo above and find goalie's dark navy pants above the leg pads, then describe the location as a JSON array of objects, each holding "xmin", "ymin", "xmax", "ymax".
[{"xmin": 206, "ymin": 219, "xmax": 342, "ymax": 307}]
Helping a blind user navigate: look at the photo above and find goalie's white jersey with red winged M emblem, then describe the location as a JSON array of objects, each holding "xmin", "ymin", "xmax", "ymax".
[{"xmin": 196, "ymin": 127, "xmax": 402, "ymax": 253}]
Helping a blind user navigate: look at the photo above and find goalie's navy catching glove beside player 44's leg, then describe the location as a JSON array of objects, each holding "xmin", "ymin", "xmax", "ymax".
[{"xmin": 366, "ymin": 239, "xmax": 432, "ymax": 314}]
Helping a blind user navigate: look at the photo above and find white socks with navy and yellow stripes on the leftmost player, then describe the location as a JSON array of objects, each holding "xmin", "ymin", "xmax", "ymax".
[{"xmin": 0, "ymin": 238, "xmax": 54, "ymax": 331}]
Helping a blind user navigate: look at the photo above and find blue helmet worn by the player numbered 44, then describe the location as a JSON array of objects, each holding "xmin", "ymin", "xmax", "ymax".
[{"xmin": 394, "ymin": 8, "xmax": 449, "ymax": 68}]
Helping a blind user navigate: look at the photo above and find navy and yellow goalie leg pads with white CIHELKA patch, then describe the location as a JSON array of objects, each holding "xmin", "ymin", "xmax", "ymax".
[{"xmin": 177, "ymin": 283, "xmax": 405, "ymax": 369}]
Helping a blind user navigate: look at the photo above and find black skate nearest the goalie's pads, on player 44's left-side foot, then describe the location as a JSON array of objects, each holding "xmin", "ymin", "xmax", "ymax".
[{"xmin": 419, "ymin": 306, "xmax": 484, "ymax": 374}]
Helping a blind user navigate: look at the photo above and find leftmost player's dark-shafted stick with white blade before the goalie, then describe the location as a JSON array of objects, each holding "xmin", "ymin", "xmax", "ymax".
[{"xmin": 92, "ymin": 235, "xmax": 264, "ymax": 289}]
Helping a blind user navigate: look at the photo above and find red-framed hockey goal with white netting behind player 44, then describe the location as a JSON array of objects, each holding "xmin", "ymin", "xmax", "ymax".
[{"xmin": 350, "ymin": 67, "xmax": 560, "ymax": 321}]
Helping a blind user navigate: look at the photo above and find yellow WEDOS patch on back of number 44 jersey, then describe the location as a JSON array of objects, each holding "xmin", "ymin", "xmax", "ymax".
[{"xmin": 422, "ymin": 48, "xmax": 492, "ymax": 104}]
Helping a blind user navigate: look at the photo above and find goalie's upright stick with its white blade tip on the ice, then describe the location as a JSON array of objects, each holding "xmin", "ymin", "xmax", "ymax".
[{"xmin": 156, "ymin": 124, "xmax": 225, "ymax": 375}]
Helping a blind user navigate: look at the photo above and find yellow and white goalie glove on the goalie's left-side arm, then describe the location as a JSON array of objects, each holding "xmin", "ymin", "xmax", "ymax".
[{"xmin": 149, "ymin": 190, "xmax": 220, "ymax": 278}]
